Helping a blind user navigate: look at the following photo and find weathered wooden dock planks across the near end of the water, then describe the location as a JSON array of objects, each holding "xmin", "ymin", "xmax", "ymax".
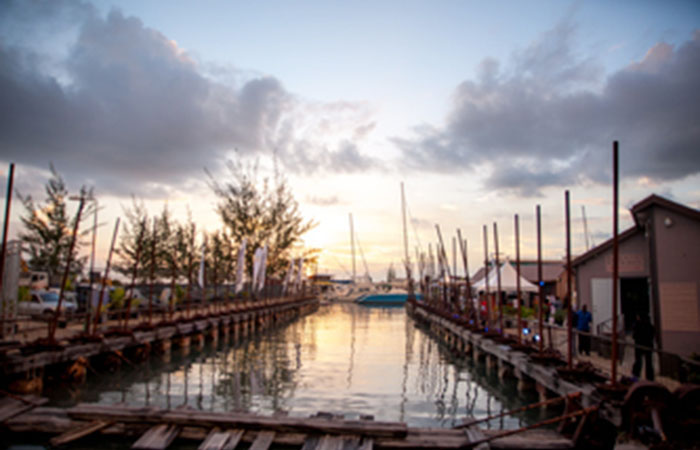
[{"xmin": 0, "ymin": 397, "xmax": 574, "ymax": 450}]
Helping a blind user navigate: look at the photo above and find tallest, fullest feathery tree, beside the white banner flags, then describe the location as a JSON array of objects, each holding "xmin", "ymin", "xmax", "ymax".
[{"xmin": 209, "ymin": 161, "xmax": 315, "ymax": 276}]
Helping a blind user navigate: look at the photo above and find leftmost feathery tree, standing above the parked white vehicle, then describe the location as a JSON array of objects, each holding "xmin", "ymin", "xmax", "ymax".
[{"xmin": 17, "ymin": 165, "xmax": 94, "ymax": 286}]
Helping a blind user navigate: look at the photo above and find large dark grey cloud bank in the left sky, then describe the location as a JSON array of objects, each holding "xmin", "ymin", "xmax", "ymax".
[{"xmin": 0, "ymin": 2, "xmax": 372, "ymax": 195}]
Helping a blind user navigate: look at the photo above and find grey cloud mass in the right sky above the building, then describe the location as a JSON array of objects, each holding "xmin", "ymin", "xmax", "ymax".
[{"xmin": 393, "ymin": 22, "xmax": 700, "ymax": 196}]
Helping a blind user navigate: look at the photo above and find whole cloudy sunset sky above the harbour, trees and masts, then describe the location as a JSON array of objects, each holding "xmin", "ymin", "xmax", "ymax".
[{"xmin": 0, "ymin": 0, "xmax": 700, "ymax": 279}]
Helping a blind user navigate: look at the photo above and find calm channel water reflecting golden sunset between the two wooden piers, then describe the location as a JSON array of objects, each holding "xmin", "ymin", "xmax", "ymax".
[{"xmin": 49, "ymin": 304, "xmax": 560, "ymax": 428}]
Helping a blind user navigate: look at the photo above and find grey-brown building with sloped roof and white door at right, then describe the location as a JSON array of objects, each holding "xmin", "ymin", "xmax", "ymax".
[{"xmin": 572, "ymin": 195, "xmax": 700, "ymax": 356}]
